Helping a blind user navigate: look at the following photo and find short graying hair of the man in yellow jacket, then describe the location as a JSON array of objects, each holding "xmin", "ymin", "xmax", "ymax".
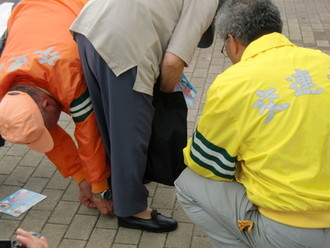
[{"xmin": 215, "ymin": 0, "xmax": 283, "ymax": 46}]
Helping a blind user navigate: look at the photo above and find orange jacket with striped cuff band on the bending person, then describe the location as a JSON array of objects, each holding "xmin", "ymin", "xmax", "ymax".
[{"xmin": 0, "ymin": 0, "xmax": 110, "ymax": 193}]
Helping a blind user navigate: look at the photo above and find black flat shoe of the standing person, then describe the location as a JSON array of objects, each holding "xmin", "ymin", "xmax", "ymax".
[{"xmin": 117, "ymin": 210, "xmax": 178, "ymax": 233}]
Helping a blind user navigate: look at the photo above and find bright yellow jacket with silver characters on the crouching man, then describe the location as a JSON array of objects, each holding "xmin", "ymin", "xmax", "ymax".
[{"xmin": 184, "ymin": 33, "xmax": 330, "ymax": 228}]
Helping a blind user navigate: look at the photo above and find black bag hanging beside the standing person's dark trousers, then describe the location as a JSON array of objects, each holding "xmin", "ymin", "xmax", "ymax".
[{"xmin": 145, "ymin": 83, "xmax": 188, "ymax": 186}]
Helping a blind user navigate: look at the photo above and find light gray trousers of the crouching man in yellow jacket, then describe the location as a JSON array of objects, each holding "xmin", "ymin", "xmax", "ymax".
[{"xmin": 175, "ymin": 168, "xmax": 330, "ymax": 248}]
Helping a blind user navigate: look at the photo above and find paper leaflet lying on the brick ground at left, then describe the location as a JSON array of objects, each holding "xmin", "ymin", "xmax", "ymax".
[{"xmin": 0, "ymin": 189, "xmax": 47, "ymax": 217}]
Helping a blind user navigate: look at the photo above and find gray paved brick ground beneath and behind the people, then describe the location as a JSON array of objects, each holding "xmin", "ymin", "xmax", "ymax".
[{"xmin": 0, "ymin": 0, "xmax": 330, "ymax": 248}]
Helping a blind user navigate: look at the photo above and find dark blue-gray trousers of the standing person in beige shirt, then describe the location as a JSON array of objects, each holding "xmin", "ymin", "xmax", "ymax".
[{"xmin": 75, "ymin": 34, "xmax": 154, "ymax": 217}]
